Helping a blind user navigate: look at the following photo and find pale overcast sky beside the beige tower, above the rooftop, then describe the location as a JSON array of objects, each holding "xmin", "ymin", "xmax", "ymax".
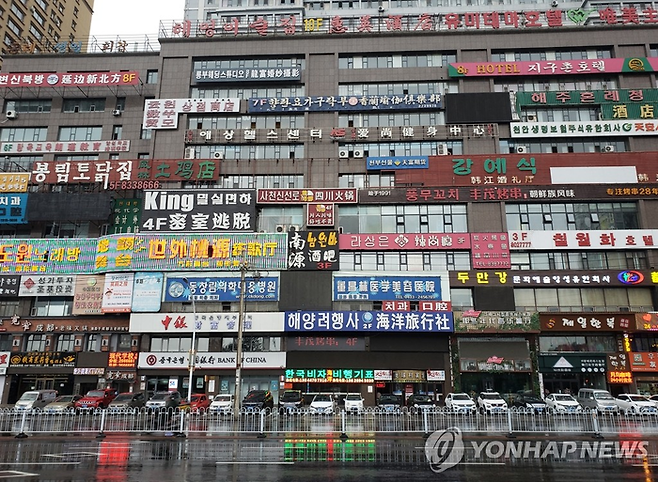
[{"xmin": 91, "ymin": 0, "xmax": 185, "ymax": 39}]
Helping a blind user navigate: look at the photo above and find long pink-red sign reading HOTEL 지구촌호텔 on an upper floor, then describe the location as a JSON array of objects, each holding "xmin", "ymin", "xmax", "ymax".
[{"xmin": 448, "ymin": 57, "xmax": 658, "ymax": 77}]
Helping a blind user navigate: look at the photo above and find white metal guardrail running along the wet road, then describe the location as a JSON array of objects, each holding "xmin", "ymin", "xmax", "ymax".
[{"xmin": 0, "ymin": 407, "xmax": 658, "ymax": 437}]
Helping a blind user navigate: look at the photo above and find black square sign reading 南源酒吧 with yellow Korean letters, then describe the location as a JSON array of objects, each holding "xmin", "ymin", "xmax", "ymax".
[{"xmin": 288, "ymin": 230, "xmax": 340, "ymax": 271}]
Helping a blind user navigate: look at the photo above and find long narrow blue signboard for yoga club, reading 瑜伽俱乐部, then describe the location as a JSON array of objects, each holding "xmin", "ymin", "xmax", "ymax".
[{"xmin": 247, "ymin": 94, "xmax": 443, "ymax": 114}]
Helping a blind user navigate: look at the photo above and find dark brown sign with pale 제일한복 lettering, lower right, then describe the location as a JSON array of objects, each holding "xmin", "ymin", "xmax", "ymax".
[{"xmin": 539, "ymin": 313, "xmax": 635, "ymax": 333}]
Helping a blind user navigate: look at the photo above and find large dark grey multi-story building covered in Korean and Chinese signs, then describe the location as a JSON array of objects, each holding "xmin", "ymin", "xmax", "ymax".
[{"xmin": 0, "ymin": 6, "xmax": 658, "ymax": 404}]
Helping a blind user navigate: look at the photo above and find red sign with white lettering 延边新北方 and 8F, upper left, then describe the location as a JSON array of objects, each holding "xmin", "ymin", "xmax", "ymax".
[{"xmin": 0, "ymin": 71, "xmax": 140, "ymax": 87}]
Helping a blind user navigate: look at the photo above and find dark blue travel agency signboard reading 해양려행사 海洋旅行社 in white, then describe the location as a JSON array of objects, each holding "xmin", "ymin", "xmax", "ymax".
[{"xmin": 284, "ymin": 311, "xmax": 454, "ymax": 333}]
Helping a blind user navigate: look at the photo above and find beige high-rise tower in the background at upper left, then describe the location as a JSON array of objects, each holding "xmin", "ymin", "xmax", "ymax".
[{"xmin": 0, "ymin": 0, "xmax": 94, "ymax": 55}]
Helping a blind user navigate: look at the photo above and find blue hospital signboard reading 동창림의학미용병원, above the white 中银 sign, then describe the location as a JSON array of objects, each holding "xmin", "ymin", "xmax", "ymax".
[{"xmin": 164, "ymin": 276, "xmax": 279, "ymax": 302}]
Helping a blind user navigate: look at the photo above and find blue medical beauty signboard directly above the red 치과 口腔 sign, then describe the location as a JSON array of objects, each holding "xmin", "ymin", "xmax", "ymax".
[{"xmin": 334, "ymin": 275, "xmax": 441, "ymax": 301}]
